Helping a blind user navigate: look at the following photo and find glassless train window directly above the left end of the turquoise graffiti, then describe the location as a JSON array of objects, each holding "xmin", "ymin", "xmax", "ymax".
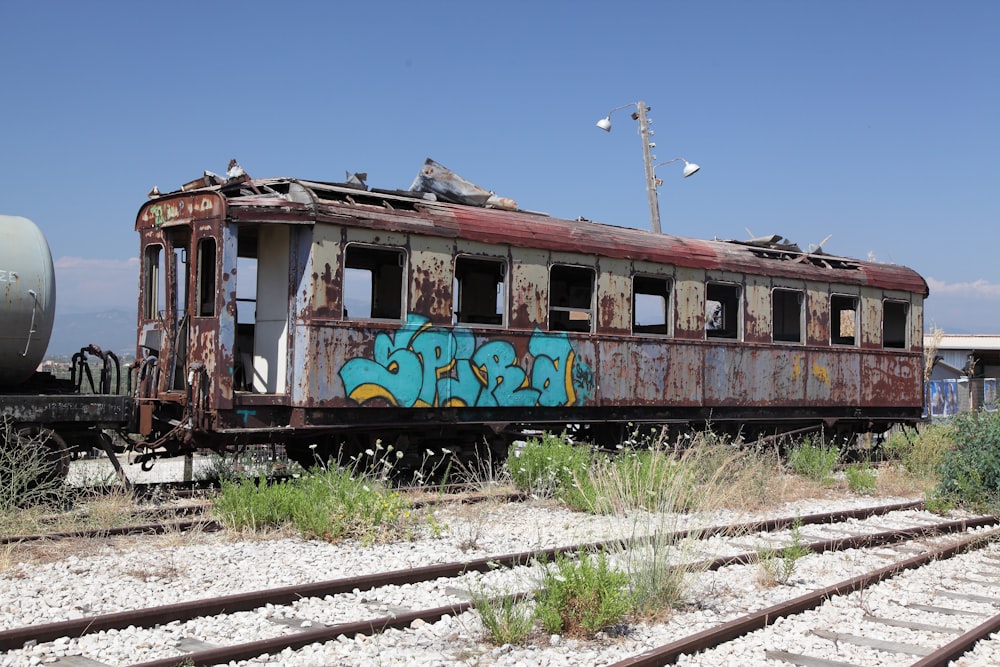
[{"xmin": 344, "ymin": 245, "xmax": 406, "ymax": 320}]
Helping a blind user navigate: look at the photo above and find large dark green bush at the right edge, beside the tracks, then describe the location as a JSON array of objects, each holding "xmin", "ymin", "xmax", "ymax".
[{"xmin": 938, "ymin": 411, "xmax": 1000, "ymax": 511}]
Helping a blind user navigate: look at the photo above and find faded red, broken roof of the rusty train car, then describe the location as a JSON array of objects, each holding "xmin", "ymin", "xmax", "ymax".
[{"xmin": 136, "ymin": 172, "xmax": 928, "ymax": 297}]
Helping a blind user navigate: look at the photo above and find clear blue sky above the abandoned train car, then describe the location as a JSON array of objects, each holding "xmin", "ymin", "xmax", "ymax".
[{"xmin": 0, "ymin": 0, "xmax": 1000, "ymax": 333}]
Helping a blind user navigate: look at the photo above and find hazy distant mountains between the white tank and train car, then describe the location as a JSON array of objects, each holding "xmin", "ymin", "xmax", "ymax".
[{"xmin": 45, "ymin": 309, "xmax": 136, "ymax": 359}]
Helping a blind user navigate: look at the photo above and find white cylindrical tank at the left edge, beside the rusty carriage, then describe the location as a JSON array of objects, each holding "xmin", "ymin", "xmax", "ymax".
[{"xmin": 0, "ymin": 215, "xmax": 56, "ymax": 388}]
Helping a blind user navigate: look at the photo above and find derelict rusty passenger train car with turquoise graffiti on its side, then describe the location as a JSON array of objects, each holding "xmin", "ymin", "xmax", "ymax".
[{"xmin": 134, "ymin": 161, "xmax": 928, "ymax": 470}]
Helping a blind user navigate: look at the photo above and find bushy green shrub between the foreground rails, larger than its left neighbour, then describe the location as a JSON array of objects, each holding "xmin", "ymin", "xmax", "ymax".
[{"xmin": 536, "ymin": 552, "xmax": 633, "ymax": 636}]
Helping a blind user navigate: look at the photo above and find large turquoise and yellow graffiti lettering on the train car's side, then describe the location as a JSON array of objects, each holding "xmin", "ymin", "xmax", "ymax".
[{"xmin": 340, "ymin": 313, "xmax": 592, "ymax": 408}]
